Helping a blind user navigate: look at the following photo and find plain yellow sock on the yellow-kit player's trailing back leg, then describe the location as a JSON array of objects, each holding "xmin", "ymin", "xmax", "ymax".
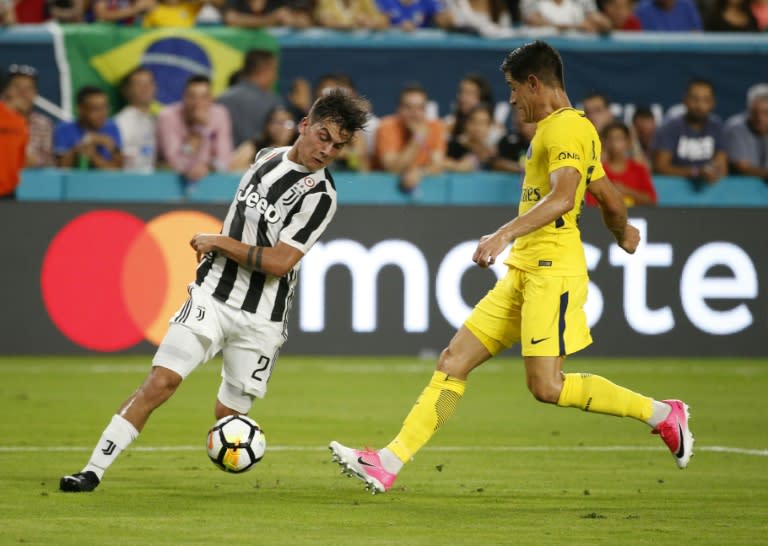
[{"xmin": 557, "ymin": 373, "xmax": 653, "ymax": 421}]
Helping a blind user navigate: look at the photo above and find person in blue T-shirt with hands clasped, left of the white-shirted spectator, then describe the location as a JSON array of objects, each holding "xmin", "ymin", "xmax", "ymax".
[{"xmin": 53, "ymin": 85, "xmax": 123, "ymax": 169}]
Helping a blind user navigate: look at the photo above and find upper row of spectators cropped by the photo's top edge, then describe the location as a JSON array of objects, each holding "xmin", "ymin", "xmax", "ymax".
[{"xmin": 0, "ymin": 0, "xmax": 768, "ymax": 32}]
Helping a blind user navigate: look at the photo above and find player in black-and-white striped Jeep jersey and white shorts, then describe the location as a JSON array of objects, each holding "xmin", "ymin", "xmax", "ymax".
[{"xmin": 59, "ymin": 89, "xmax": 369, "ymax": 492}]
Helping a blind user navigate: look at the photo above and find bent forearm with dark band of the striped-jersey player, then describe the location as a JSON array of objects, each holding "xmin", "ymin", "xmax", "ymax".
[{"xmin": 189, "ymin": 233, "xmax": 304, "ymax": 277}]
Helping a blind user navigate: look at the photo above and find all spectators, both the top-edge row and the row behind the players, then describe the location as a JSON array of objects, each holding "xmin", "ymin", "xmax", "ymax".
[{"xmin": 0, "ymin": 0, "xmax": 768, "ymax": 200}]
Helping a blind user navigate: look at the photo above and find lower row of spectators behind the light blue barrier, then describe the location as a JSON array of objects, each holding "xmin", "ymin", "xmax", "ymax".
[{"xmin": 0, "ymin": 46, "xmax": 768, "ymax": 205}]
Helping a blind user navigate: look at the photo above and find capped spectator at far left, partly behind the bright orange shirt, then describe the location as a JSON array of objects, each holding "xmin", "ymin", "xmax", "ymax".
[{"xmin": 5, "ymin": 64, "xmax": 53, "ymax": 168}]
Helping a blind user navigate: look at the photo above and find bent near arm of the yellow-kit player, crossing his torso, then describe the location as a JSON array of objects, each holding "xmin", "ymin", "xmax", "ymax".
[{"xmin": 472, "ymin": 167, "xmax": 581, "ymax": 267}]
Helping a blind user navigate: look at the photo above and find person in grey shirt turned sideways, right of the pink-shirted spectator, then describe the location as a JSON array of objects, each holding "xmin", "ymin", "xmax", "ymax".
[{"xmin": 217, "ymin": 49, "xmax": 282, "ymax": 146}]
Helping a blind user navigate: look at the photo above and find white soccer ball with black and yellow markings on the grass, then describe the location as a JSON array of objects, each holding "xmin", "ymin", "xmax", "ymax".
[{"xmin": 206, "ymin": 415, "xmax": 267, "ymax": 473}]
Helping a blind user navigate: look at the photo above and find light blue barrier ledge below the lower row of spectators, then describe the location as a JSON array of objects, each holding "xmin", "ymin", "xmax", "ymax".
[{"xmin": 18, "ymin": 169, "xmax": 768, "ymax": 207}]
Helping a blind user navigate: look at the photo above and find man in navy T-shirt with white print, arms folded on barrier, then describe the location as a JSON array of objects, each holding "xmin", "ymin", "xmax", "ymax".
[{"xmin": 653, "ymin": 80, "xmax": 728, "ymax": 184}]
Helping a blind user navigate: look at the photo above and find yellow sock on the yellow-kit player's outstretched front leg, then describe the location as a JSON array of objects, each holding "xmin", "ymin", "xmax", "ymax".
[{"xmin": 387, "ymin": 372, "xmax": 467, "ymax": 463}]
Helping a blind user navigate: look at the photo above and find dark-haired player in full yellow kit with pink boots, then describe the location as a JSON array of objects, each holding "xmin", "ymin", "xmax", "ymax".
[{"xmin": 329, "ymin": 41, "xmax": 693, "ymax": 493}]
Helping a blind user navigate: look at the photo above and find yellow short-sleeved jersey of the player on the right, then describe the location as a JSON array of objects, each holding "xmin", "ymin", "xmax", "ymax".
[{"xmin": 505, "ymin": 108, "xmax": 605, "ymax": 276}]
